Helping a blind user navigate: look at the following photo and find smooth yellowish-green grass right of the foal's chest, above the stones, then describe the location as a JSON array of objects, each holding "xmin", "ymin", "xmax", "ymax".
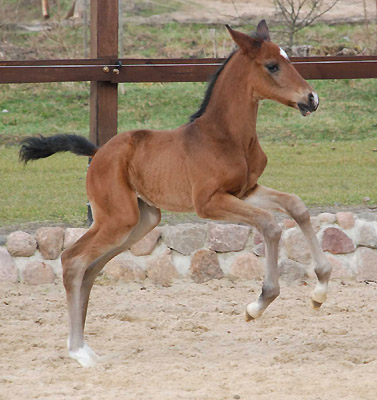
[{"xmin": 260, "ymin": 141, "xmax": 377, "ymax": 206}]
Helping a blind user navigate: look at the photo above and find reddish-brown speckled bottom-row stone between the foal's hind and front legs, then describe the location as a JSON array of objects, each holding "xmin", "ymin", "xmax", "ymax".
[{"xmin": 190, "ymin": 249, "xmax": 224, "ymax": 283}]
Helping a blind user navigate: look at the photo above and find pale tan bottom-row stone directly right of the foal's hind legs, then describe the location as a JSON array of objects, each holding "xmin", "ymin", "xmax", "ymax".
[{"xmin": 105, "ymin": 254, "xmax": 147, "ymax": 282}]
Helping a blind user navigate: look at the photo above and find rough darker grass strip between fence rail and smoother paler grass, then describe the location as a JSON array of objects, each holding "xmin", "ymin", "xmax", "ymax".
[{"xmin": 0, "ymin": 79, "xmax": 377, "ymax": 144}]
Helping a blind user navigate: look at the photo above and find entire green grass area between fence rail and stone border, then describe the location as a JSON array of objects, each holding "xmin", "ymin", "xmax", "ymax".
[{"xmin": 0, "ymin": 80, "xmax": 377, "ymax": 226}]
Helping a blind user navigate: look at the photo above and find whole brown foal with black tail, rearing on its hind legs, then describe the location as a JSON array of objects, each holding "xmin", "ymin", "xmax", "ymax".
[{"xmin": 20, "ymin": 20, "xmax": 331, "ymax": 366}]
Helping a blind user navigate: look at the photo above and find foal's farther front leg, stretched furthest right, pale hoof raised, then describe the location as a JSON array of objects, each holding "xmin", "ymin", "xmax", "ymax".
[{"xmin": 245, "ymin": 186, "xmax": 331, "ymax": 309}]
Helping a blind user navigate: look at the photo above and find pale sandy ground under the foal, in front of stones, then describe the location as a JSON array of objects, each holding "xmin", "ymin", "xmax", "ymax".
[{"xmin": 0, "ymin": 279, "xmax": 377, "ymax": 400}]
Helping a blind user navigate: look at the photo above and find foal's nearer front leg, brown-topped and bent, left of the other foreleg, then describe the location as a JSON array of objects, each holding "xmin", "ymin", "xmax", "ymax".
[{"xmin": 195, "ymin": 193, "xmax": 281, "ymax": 321}]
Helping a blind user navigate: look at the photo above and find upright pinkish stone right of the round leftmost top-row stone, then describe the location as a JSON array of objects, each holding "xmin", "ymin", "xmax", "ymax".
[{"xmin": 35, "ymin": 227, "xmax": 64, "ymax": 260}]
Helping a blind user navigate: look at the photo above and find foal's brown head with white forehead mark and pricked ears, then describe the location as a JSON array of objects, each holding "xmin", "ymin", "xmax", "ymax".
[{"xmin": 227, "ymin": 20, "xmax": 318, "ymax": 116}]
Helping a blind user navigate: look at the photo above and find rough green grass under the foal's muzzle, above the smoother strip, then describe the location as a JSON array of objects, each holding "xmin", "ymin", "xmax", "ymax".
[{"xmin": 258, "ymin": 79, "xmax": 377, "ymax": 142}]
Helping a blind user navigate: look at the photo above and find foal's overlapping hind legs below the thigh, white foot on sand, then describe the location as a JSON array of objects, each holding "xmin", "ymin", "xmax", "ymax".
[{"xmin": 62, "ymin": 196, "xmax": 160, "ymax": 366}]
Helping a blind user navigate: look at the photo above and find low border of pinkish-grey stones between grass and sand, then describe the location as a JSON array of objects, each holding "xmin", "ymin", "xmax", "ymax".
[{"xmin": 0, "ymin": 212, "xmax": 377, "ymax": 286}]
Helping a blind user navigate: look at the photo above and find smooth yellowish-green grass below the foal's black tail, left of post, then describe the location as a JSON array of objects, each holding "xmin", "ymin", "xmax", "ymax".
[{"xmin": 0, "ymin": 147, "xmax": 88, "ymax": 226}]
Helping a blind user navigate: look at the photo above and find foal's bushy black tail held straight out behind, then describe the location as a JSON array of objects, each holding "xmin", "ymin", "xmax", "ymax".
[{"xmin": 19, "ymin": 135, "xmax": 98, "ymax": 164}]
